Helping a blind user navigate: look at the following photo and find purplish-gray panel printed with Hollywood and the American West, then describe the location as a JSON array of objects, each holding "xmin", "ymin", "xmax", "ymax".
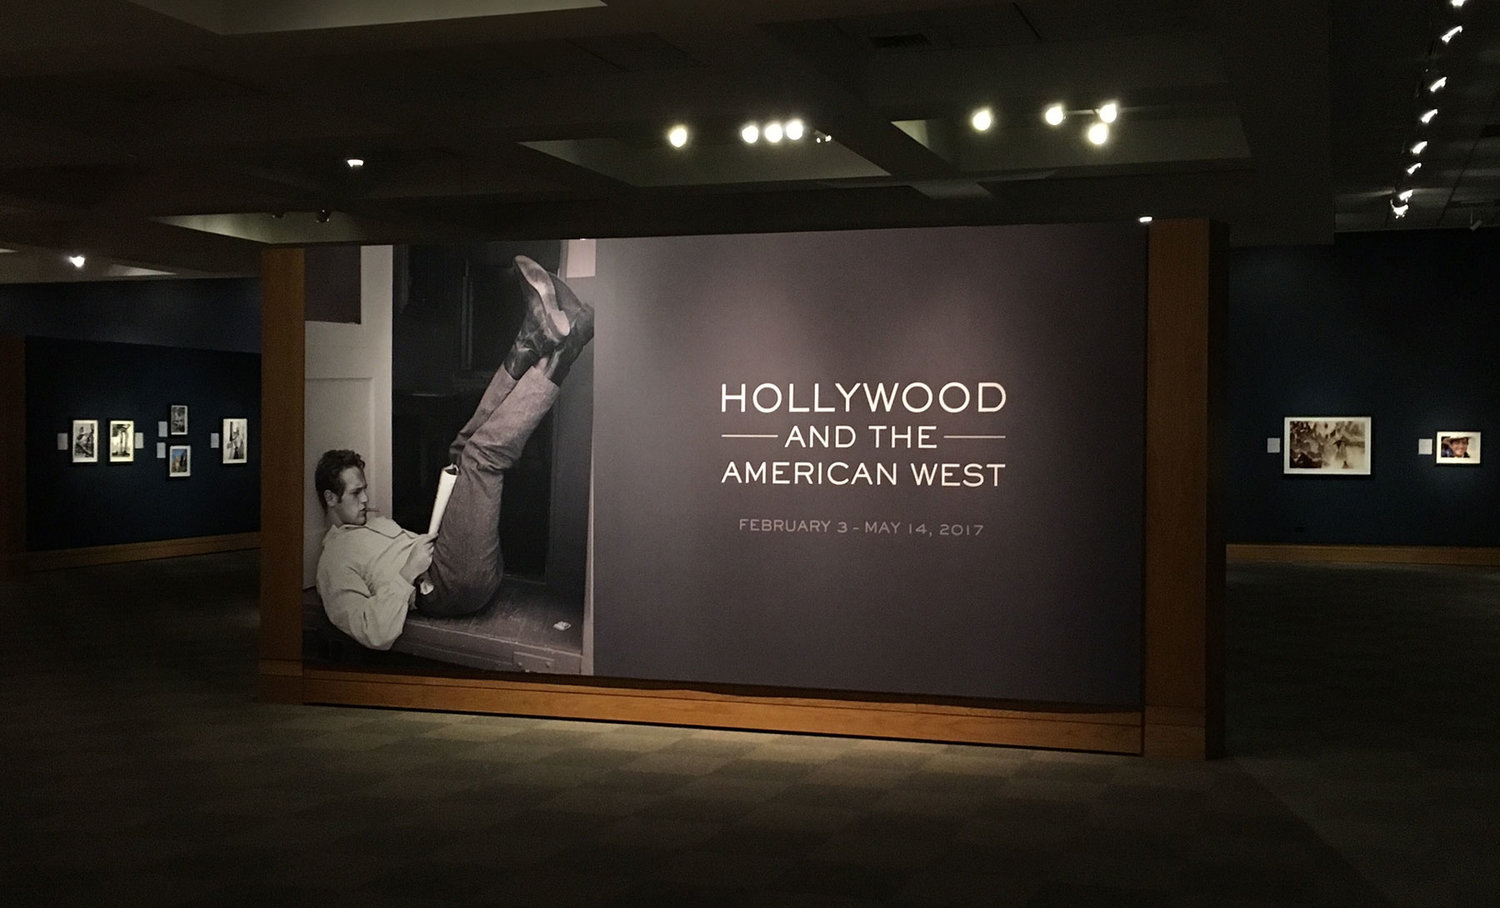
[{"xmin": 594, "ymin": 225, "xmax": 1146, "ymax": 704}]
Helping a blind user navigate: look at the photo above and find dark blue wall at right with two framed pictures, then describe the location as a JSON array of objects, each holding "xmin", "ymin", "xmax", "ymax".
[{"xmin": 1226, "ymin": 230, "xmax": 1500, "ymax": 546}]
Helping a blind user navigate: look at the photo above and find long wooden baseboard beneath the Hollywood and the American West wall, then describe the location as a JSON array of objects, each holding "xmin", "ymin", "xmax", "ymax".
[{"xmin": 302, "ymin": 668, "xmax": 1142, "ymax": 755}]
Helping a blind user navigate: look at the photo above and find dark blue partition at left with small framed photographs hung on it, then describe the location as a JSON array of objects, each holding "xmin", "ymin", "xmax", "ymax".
[{"xmin": 26, "ymin": 338, "xmax": 261, "ymax": 551}]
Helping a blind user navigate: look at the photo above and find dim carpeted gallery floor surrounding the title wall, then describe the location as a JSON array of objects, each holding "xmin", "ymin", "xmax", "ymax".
[{"xmin": 0, "ymin": 552, "xmax": 1500, "ymax": 908}]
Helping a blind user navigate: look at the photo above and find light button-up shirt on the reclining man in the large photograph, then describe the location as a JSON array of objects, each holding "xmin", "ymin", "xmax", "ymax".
[{"xmin": 318, "ymin": 516, "xmax": 417, "ymax": 650}]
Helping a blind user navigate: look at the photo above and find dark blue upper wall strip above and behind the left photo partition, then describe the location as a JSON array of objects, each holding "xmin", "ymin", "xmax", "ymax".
[{"xmin": 0, "ymin": 278, "xmax": 261, "ymax": 354}]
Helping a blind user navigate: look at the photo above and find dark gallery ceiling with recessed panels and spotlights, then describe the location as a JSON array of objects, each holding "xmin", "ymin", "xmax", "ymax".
[{"xmin": 0, "ymin": 0, "xmax": 1500, "ymax": 281}]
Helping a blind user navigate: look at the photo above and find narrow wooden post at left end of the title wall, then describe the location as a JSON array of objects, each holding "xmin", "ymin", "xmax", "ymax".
[{"xmin": 257, "ymin": 249, "xmax": 306, "ymax": 702}]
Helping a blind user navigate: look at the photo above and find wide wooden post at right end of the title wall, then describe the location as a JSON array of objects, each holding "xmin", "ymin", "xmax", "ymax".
[{"xmin": 1142, "ymin": 221, "xmax": 1226, "ymax": 759}]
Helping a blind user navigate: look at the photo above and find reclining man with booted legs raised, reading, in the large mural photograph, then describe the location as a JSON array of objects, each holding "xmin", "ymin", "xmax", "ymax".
[{"xmin": 314, "ymin": 255, "xmax": 594, "ymax": 650}]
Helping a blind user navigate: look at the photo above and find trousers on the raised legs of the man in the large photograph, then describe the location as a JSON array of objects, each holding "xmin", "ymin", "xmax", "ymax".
[{"xmin": 419, "ymin": 369, "xmax": 558, "ymax": 617}]
